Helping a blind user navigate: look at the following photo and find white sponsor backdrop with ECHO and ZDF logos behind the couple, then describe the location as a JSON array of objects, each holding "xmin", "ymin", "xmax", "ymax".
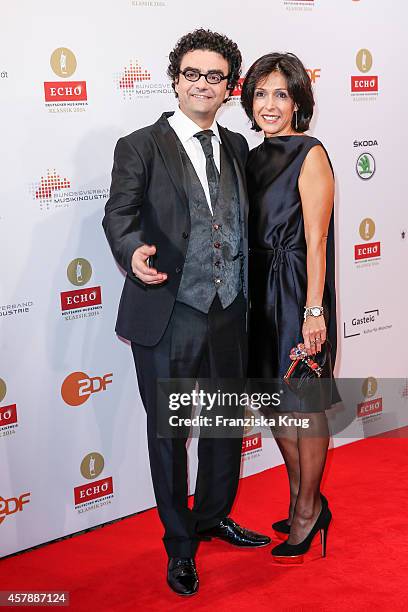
[{"xmin": 0, "ymin": 0, "xmax": 408, "ymax": 556}]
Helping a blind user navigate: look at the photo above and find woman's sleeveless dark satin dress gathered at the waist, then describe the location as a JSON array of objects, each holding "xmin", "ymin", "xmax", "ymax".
[{"xmin": 247, "ymin": 135, "xmax": 338, "ymax": 411}]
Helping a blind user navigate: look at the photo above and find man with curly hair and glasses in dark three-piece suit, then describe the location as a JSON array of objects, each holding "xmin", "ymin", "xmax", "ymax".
[{"xmin": 103, "ymin": 29, "xmax": 270, "ymax": 595}]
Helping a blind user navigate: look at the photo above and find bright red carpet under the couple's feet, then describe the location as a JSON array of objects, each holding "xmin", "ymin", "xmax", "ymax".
[{"xmin": 0, "ymin": 437, "xmax": 408, "ymax": 612}]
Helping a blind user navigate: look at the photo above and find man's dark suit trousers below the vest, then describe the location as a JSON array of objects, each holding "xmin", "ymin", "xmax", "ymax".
[{"xmin": 132, "ymin": 293, "xmax": 247, "ymax": 557}]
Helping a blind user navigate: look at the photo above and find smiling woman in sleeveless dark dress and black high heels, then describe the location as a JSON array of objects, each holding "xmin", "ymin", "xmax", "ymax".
[{"xmin": 241, "ymin": 53, "xmax": 337, "ymax": 563}]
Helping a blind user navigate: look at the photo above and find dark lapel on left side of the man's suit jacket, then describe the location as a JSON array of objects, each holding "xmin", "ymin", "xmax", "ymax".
[{"xmin": 152, "ymin": 113, "xmax": 188, "ymax": 205}]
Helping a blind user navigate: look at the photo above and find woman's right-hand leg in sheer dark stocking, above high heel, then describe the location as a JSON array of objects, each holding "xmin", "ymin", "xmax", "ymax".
[{"xmin": 288, "ymin": 412, "xmax": 329, "ymax": 544}]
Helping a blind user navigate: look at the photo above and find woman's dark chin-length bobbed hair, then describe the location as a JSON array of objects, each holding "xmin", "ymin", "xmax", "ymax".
[{"xmin": 241, "ymin": 53, "xmax": 314, "ymax": 132}]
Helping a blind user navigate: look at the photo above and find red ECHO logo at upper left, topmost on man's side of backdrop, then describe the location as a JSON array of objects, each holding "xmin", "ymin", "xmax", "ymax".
[{"xmin": 44, "ymin": 47, "xmax": 88, "ymax": 112}]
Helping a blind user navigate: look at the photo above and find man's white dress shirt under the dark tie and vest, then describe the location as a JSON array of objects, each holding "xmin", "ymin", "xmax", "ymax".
[{"xmin": 168, "ymin": 108, "xmax": 221, "ymax": 215}]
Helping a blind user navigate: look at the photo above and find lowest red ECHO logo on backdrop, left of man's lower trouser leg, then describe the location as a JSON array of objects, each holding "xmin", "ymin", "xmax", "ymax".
[{"xmin": 74, "ymin": 452, "xmax": 113, "ymax": 513}]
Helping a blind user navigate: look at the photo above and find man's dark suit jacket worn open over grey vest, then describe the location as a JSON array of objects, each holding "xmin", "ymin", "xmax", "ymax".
[{"xmin": 102, "ymin": 113, "xmax": 248, "ymax": 346}]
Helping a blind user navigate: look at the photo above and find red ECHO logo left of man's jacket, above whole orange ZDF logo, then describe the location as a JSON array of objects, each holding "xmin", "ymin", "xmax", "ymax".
[{"xmin": 60, "ymin": 257, "xmax": 102, "ymax": 321}]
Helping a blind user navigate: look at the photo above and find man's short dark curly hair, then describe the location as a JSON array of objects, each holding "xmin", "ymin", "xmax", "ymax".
[{"xmin": 167, "ymin": 28, "xmax": 242, "ymax": 102}]
